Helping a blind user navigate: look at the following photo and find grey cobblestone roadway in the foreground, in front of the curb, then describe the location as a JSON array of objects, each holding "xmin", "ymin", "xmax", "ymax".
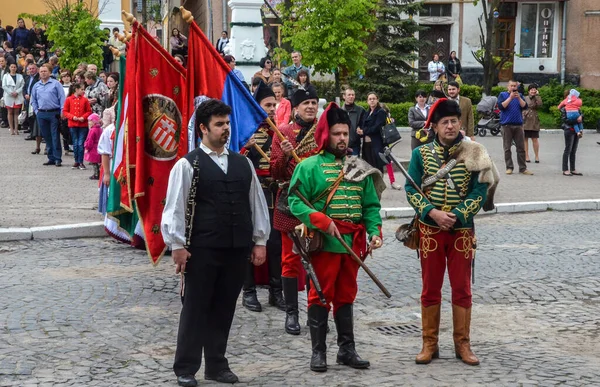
[{"xmin": 0, "ymin": 211, "xmax": 600, "ymax": 387}]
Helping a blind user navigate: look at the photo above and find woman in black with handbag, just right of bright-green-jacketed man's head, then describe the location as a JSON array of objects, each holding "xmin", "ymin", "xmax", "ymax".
[{"xmin": 356, "ymin": 92, "xmax": 387, "ymax": 172}]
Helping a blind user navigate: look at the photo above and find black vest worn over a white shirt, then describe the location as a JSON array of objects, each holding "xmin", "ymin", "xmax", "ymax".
[{"xmin": 185, "ymin": 148, "xmax": 253, "ymax": 249}]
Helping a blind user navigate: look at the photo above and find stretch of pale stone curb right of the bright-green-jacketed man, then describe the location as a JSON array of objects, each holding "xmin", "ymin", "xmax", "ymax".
[{"xmin": 380, "ymin": 199, "xmax": 600, "ymax": 219}]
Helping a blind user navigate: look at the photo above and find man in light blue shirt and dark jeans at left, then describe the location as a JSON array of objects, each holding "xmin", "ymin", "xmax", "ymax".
[{"xmin": 31, "ymin": 63, "xmax": 65, "ymax": 167}]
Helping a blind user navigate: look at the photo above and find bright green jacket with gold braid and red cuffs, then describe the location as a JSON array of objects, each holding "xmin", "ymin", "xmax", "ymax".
[{"xmin": 288, "ymin": 151, "xmax": 382, "ymax": 254}]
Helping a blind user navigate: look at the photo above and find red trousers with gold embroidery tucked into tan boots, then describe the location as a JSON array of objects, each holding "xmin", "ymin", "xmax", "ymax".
[{"xmin": 419, "ymin": 223, "xmax": 474, "ymax": 308}]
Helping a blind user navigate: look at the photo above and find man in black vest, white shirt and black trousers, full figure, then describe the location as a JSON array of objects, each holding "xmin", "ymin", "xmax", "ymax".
[{"xmin": 161, "ymin": 99, "xmax": 270, "ymax": 386}]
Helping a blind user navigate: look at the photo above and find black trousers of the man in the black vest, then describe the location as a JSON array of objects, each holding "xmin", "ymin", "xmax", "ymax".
[{"xmin": 173, "ymin": 248, "xmax": 250, "ymax": 376}]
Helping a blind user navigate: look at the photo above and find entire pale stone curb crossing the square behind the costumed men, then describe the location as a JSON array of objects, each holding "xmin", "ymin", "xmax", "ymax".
[{"xmin": 0, "ymin": 199, "xmax": 600, "ymax": 242}]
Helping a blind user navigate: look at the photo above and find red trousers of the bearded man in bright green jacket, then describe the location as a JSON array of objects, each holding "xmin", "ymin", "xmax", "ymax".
[{"xmin": 308, "ymin": 251, "xmax": 359, "ymax": 316}]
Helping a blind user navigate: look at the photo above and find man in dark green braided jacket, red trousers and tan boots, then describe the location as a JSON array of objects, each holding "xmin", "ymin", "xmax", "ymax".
[{"xmin": 405, "ymin": 98, "xmax": 498, "ymax": 365}]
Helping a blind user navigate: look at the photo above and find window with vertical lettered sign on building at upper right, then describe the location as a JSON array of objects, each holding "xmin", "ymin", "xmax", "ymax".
[{"xmin": 519, "ymin": 3, "xmax": 555, "ymax": 58}]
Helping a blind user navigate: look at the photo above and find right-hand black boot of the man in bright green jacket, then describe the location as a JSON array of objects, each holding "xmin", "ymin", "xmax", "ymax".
[{"xmin": 334, "ymin": 304, "xmax": 371, "ymax": 369}]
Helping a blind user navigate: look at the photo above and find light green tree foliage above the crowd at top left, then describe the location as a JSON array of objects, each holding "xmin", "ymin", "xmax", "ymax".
[{"xmin": 19, "ymin": 1, "xmax": 106, "ymax": 70}]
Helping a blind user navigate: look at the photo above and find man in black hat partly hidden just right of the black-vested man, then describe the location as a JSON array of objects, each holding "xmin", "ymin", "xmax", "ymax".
[{"xmin": 240, "ymin": 82, "xmax": 285, "ymax": 312}]
